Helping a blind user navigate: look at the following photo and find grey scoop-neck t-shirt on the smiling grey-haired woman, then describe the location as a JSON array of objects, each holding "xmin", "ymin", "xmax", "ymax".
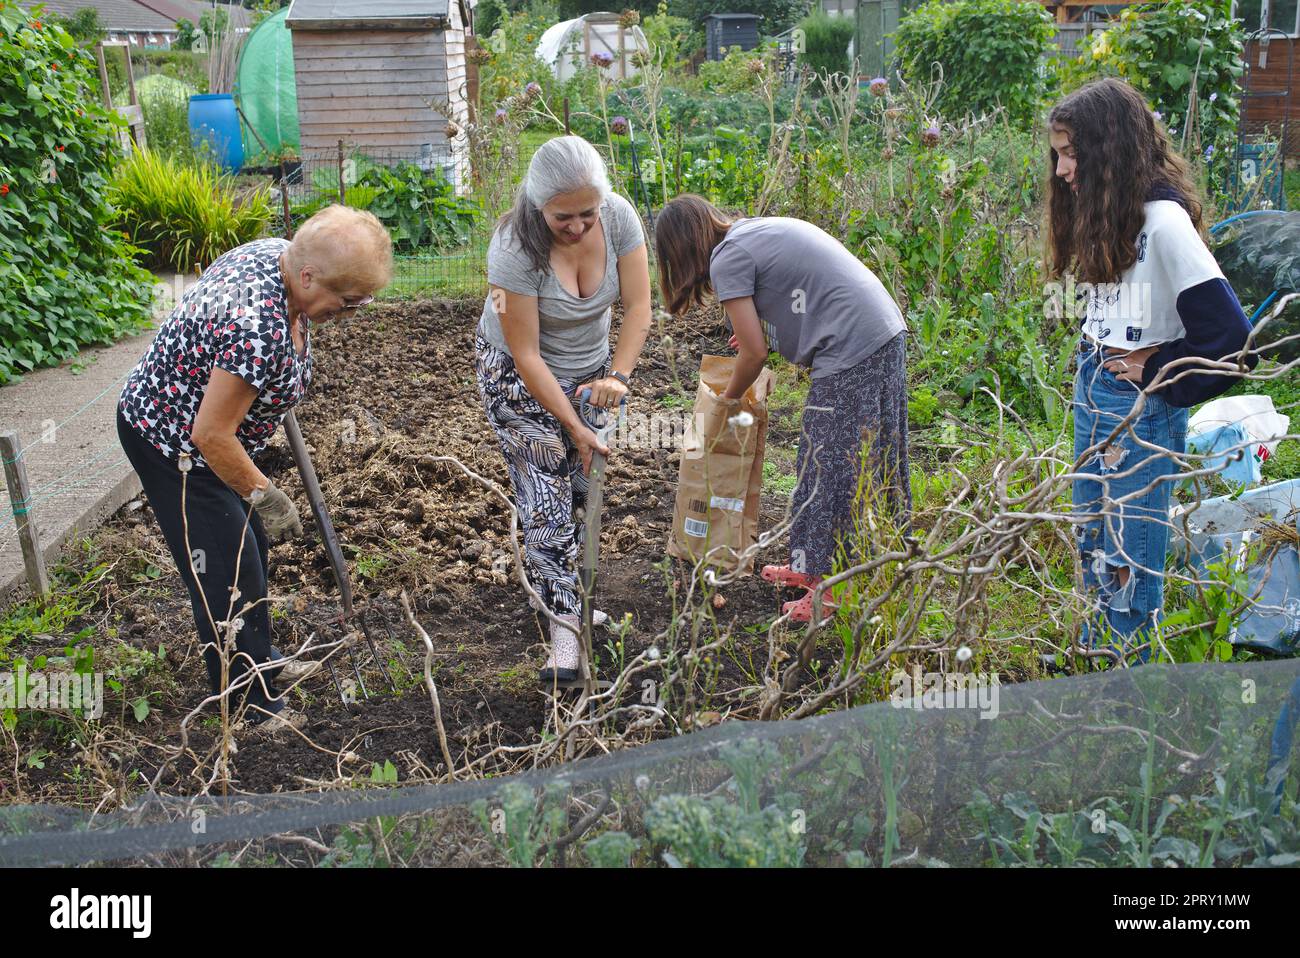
[{"xmin": 478, "ymin": 192, "xmax": 646, "ymax": 377}]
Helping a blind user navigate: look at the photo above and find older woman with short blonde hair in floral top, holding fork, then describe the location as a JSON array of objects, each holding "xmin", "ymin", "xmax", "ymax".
[{"xmin": 117, "ymin": 205, "xmax": 393, "ymax": 729}]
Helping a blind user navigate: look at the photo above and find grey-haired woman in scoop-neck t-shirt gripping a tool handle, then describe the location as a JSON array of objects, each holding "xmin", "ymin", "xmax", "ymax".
[{"xmin": 475, "ymin": 136, "xmax": 650, "ymax": 688}]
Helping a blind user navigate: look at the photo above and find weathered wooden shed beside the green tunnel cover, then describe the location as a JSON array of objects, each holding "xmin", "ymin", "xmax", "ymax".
[{"xmin": 285, "ymin": 0, "xmax": 469, "ymax": 170}]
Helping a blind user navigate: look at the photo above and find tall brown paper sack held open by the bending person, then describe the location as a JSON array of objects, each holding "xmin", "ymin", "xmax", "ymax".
[{"xmin": 668, "ymin": 356, "xmax": 772, "ymax": 576}]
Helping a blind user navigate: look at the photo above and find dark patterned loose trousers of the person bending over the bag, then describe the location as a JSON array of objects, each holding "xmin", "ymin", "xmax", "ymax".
[{"xmin": 790, "ymin": 333, "xmax": 911, "ymax": 576}]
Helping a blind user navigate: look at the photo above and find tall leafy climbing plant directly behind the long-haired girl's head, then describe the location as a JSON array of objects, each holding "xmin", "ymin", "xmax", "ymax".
[{"xmin": 1075, "ymin": 0, "xmax": 1244, "ymax": 196}]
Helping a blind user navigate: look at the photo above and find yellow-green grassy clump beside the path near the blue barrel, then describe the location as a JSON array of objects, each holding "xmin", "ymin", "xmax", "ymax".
[{"xmin": 109, "ymin": 149, "xmax": 274, "ymax": 273}]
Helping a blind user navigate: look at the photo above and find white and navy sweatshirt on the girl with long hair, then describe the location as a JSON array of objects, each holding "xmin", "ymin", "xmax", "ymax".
[{"xmin": 1083, "ymin": 186, "xmax": 1258, "ymax": 407}]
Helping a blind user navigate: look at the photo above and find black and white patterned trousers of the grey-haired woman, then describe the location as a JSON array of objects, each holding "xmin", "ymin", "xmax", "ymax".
[{"xmin": 475, "ymin": 337, "xmax": 608, "ymax": 615}]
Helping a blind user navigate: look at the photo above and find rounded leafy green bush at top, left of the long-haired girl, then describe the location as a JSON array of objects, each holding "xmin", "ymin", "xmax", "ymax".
[{"xmin": 896, "ymin": 0, "xmax": 1056, "ymax": 127}]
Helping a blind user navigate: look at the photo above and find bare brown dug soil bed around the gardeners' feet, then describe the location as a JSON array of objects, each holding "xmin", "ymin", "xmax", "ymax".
[{"xmin": 0, "ymin": 300, "xmax": 811, "ymax": 807}]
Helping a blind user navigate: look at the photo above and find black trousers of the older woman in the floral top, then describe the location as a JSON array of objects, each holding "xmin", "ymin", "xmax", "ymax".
[{"xmin": 117, "ymin": 411, "xmax": 283, "ymax": 720}]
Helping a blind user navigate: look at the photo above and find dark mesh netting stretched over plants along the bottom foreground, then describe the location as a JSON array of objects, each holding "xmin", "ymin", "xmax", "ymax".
[{"xmin": 0, "ymin": 660, "xmax": 1300, "ymax": 866}]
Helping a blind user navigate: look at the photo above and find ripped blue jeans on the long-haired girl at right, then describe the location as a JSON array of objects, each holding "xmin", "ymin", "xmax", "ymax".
[{"xmin": 1073, "ymin": 341, "xmax": 1187, "ymax": 660}]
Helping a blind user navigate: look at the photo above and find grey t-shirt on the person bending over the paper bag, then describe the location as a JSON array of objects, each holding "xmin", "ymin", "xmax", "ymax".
[{"xmin": 709, "ymin": 216, "xmax": 907, "ymax": 380}]
